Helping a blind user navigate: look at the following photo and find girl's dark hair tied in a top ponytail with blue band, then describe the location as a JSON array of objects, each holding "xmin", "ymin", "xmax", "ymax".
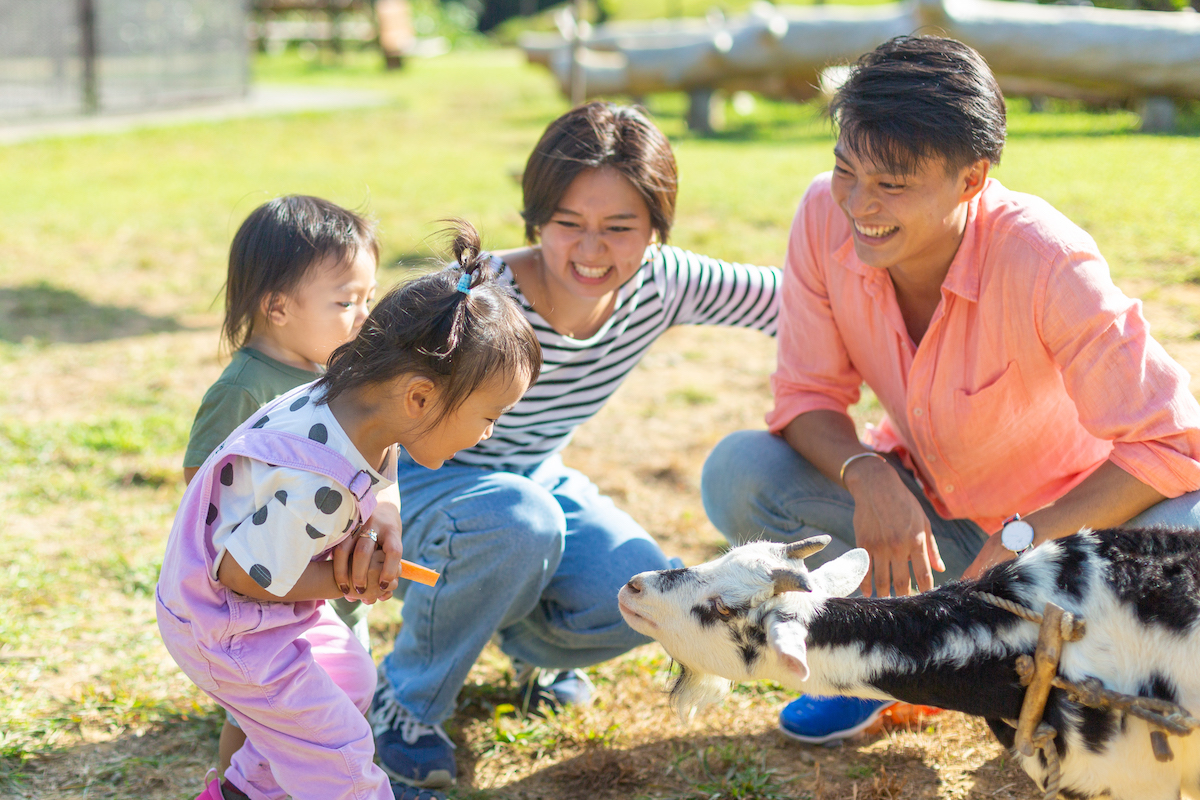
[{"xmin": 317, "ymin": 219, "xmax": 541, "ymax": 425}]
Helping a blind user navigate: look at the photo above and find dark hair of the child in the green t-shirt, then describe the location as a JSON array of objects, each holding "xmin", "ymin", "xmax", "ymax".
[{"xmin": 221, "ymin": 194, "xmax": 379, "ymax": 350}]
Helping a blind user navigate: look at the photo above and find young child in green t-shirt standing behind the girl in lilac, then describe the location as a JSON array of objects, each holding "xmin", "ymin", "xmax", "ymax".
[{"xmin": 184, "ymin": 196, "xmax": 379, "ymax": 772}]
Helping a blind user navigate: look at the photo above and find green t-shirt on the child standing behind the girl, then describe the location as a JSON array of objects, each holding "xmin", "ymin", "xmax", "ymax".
[{"xmin": 184, "ymin": 347, "xmax": 319, "ymax": 469}]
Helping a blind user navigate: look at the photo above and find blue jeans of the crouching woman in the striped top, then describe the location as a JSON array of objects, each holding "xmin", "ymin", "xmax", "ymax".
[{"xmin": 383, "ymin": 456, "xmax": 673, "ymax": 724}]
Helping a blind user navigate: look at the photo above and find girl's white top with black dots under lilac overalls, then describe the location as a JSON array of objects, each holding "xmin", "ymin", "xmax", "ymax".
[{"xmin": 208, "ymin": 383, "xmax": 396, "ymax": 597}]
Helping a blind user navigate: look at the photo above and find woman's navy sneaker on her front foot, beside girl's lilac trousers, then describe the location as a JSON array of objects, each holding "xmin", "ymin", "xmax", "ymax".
[{"xmin": 368, "ymin": 669, "xmax": 458, "ymax": 786}]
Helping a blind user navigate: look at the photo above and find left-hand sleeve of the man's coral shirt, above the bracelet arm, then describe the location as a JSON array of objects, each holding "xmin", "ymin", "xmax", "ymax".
[{"xmin": 767, "ymin": 179, "xmax": 863, "ymax": 433}]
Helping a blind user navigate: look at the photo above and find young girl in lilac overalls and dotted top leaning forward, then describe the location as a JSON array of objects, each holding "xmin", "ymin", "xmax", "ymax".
[{"xmin": 156, "ymin": 224, "xmax": 541, "ymax": 800}]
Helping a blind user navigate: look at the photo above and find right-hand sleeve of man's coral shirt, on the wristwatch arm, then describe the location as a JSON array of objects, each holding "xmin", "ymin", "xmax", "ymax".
[{"xmin": 1038, "ymin": 249, "xmax": 1200, "ymax": 498}]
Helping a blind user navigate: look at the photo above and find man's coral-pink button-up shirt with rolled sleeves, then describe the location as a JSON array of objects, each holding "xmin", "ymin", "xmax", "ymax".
[{"xmin": 767, "ymin": 173, "xmax": 1200, "ymax": 531}]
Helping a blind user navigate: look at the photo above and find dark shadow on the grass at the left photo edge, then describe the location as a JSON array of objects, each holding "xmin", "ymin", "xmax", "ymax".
[{"xmin": 0, "ymin": 281, "xmax": 182, "ymax": 344}]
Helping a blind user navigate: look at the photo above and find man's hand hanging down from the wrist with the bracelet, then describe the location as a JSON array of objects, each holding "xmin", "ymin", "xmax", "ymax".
[{"xmin": 845, "ymin": 458, "xmax": 946, "ymax": 597}]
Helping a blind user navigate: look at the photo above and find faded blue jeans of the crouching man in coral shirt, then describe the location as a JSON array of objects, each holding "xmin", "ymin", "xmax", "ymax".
[{"xmin": 700, "ymin": 431, "xmax": 1200, "ymax": 584}]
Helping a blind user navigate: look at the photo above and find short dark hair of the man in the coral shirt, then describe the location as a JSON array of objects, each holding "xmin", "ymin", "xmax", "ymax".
[{"xmin": 829, "ymin": 36, "xmax": 1006, "ymax": 175}]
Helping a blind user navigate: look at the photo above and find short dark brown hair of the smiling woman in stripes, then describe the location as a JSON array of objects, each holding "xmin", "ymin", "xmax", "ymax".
[{"xmin": 521, "ymin": 101, "xmax": 679, "ymax": 243}]
